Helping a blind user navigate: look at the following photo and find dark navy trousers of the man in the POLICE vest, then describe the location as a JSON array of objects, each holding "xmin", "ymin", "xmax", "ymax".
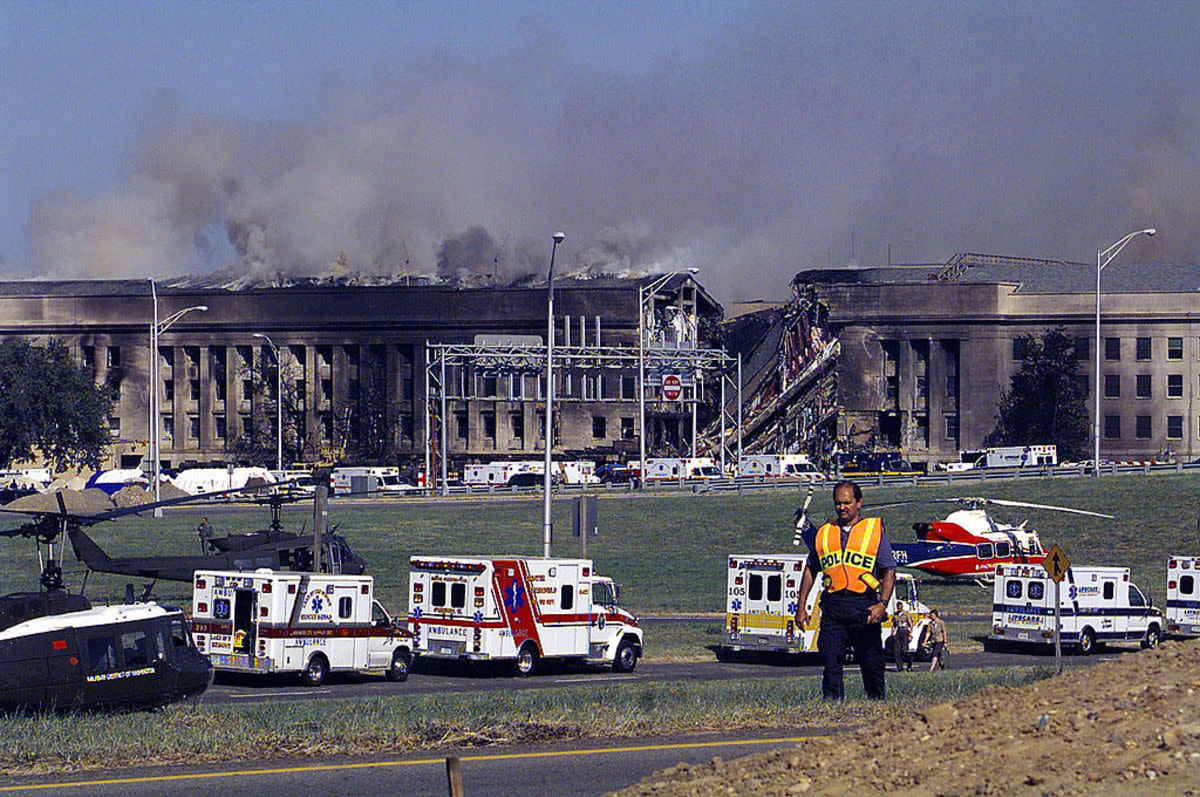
[{"xmin": 817, "ymin": 592, "xmax": 884, "ymax": 700}]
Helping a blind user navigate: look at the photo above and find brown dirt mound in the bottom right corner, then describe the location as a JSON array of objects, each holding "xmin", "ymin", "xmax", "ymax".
[{"xmin": 618, "ymin": 640, "xmax": 1200, "ymax": 797}]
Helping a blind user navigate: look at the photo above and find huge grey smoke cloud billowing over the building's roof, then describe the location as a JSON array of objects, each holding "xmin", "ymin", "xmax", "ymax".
[{"xmin": 18, "ymin": 2, "xmax": 1200, "ymax": 300}]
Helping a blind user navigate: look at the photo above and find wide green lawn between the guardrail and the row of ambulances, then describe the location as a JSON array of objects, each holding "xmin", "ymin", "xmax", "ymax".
[{"xmin": 0, "ymin": 474, "xmax": 1200, "ymax": 649}]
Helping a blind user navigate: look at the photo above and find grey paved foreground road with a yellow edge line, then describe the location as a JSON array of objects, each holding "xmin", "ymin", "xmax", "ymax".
[{"xmin": 0, "ymin": 729, "xmax": 828, "ymax": 797}]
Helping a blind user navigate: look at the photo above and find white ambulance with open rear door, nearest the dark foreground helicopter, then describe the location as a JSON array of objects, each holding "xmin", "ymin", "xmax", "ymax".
[{"xmin": 192, "ymin": 568, "xmax": 413, "ymax": 687}]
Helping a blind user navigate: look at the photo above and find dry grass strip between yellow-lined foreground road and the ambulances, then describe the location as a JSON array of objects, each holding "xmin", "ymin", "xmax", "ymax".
[{"xmin": 0, "ymin": 667, "xmax": 1051, "ymax": 774}]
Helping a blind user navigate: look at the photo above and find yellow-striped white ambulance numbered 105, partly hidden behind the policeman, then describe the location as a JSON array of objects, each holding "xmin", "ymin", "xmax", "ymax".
[{"xmin": 718, "ymin": 553, "xmax": 930, "ymax": 659}]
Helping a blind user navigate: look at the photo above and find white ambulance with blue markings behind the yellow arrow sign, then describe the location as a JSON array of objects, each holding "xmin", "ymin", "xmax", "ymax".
[{"xmin": 984, "ymin": 564, "xmax": 1164, "ymax": 655}]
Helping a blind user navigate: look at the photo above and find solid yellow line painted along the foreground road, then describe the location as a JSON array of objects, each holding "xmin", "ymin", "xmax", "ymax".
[{"xmin": 0, "ymin": 736, "xmax": 811, "ymax": 792}]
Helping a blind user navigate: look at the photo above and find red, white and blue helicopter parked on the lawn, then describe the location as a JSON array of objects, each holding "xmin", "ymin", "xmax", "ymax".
[{"xmin": 872, "ymin": 498, "xmax": 1112, "ymax": 586}]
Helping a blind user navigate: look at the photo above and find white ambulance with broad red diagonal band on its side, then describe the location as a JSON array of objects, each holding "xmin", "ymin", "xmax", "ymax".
[{"xmin": 408, "ymin": 556, "xmax": 642, "ymax": 676}]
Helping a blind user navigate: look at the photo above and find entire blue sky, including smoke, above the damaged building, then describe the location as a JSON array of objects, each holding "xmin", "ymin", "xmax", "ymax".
[{"xmin": 0, "ymin": 0, "xmax": 1200, "ymax": 298}]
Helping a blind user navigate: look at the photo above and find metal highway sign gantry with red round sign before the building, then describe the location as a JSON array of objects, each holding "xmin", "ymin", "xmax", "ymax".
[{"xmin": 425, "ymin": 336, "xmax": 742, "ymax": 495}]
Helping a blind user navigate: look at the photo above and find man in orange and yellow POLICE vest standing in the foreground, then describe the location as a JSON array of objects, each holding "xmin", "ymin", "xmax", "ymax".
[{"xmin": 796, "ymin": 481, "xmax": 896, "ymax": 700}]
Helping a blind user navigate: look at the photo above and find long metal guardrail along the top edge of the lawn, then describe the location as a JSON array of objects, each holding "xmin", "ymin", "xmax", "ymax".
[{"xmin": 335, "ymin": 462, "xmax": 1200, "ymax": 501}]
